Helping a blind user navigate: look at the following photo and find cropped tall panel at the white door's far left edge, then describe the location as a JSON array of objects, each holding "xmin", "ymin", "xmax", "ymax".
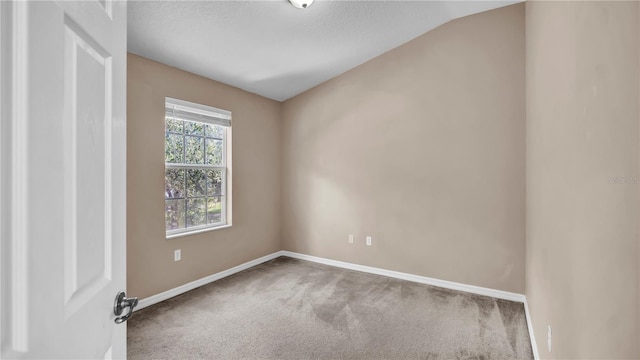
[{"xmin": 0, "ymin": 1, "xmax": 29, "ymax": 352}]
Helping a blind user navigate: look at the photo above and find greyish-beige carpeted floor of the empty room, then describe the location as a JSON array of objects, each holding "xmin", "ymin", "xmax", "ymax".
[{"xmin": 128, "ymin": 257, "xmax": 533, "ymax": 360}]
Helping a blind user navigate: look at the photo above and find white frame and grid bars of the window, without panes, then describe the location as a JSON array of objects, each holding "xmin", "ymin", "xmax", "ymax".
[{"xmin": 163, "ymin": 97, "xmax": 231, "ymax": 239}]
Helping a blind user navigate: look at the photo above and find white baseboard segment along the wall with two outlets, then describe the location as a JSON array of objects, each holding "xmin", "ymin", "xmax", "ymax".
[{"xmin": 280, "ymin": 251, "xmax": 525, "ymax": 303}]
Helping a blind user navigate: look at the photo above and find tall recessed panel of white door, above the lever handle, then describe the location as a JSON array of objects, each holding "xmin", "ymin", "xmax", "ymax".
[{"xmin": 63, "ymin": 13, "xmax": 112, "ymax": 313}]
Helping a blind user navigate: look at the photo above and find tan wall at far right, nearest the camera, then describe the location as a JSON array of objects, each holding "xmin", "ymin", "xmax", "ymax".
[{"xmin": 526, "ymin": 1, "xmax": 640, "ymax": 359}]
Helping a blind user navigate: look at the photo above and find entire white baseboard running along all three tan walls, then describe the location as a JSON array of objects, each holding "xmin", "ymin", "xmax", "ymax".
[{"xmin": 135, "ymin": 251, "xmax": 540, "ymax": 360}]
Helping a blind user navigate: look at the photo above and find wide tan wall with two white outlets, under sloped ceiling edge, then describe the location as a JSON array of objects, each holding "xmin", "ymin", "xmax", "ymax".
[{"xmin": 282, "ymin": 4, "xmax": 525, "ymax": 293}]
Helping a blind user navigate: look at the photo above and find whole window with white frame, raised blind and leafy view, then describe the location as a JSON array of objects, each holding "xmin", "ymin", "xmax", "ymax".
[{"xmin": 164, "ymin": 98, "xmax": 231, "ymax": 237}]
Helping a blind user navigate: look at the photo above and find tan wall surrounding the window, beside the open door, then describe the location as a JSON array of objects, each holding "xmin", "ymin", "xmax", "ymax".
[{"xmin": 127, "ymin": 54, "xmax": 282, "ymax": 298}]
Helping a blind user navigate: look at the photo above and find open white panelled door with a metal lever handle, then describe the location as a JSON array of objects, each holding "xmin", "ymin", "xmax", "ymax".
[{"xmin": 0, "ymin": 0, "xmax": 127, "ymax": 359}]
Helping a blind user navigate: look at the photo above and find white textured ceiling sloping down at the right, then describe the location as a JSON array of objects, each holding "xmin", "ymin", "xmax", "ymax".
[{"xmin": 128, "ymin": 0, "xmax": 519, "ymax": 101}]
